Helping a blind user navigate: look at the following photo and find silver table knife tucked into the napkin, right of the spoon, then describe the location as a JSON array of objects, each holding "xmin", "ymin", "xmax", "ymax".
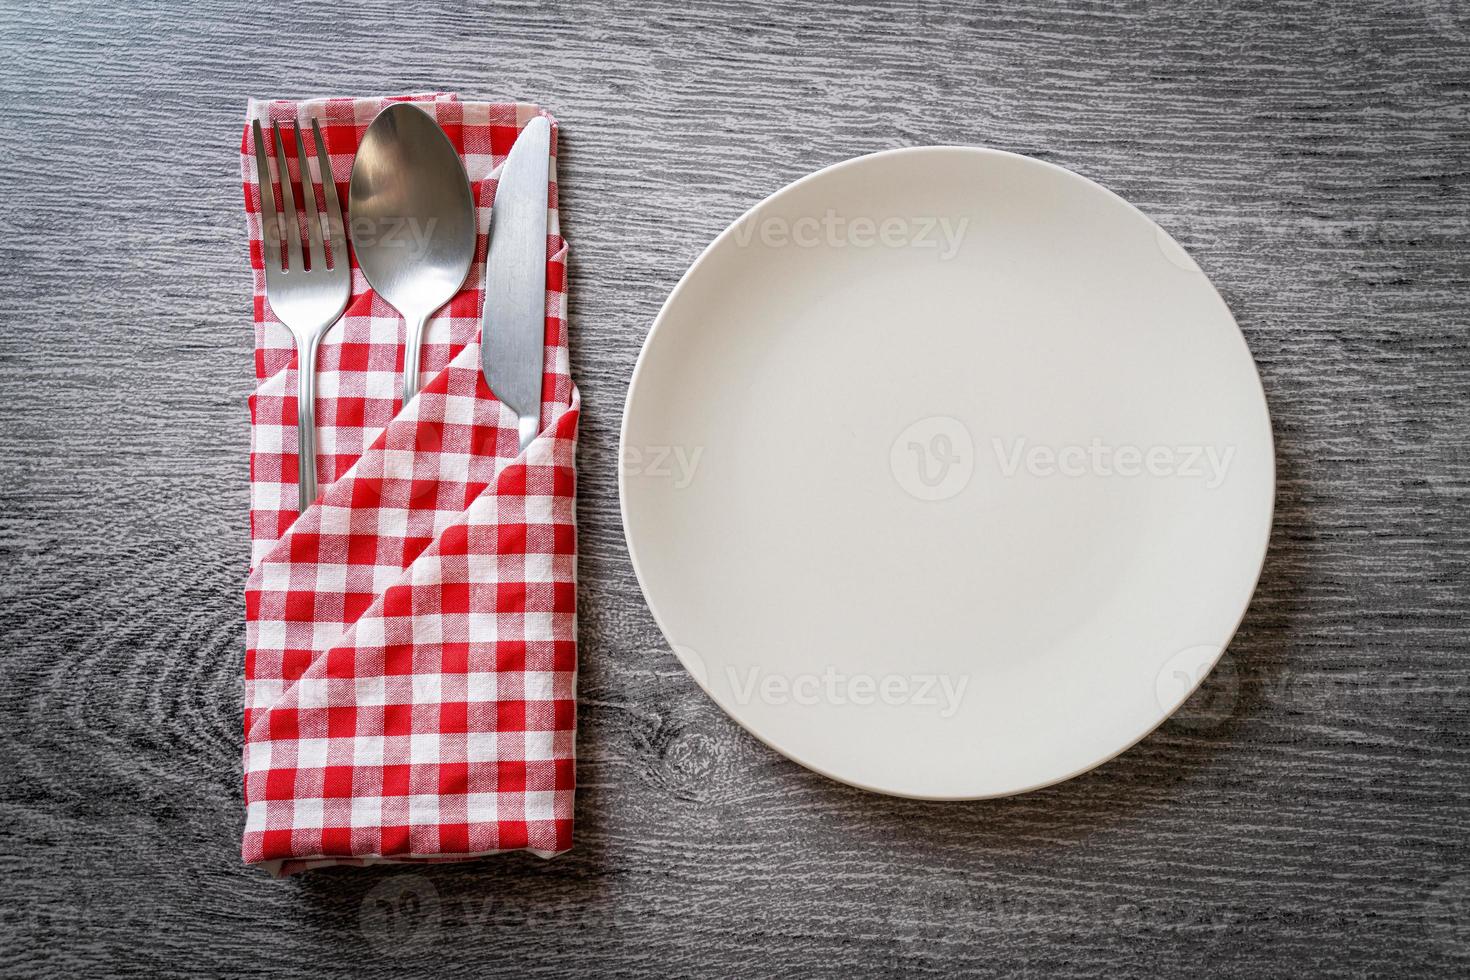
[{"xmin": 479, "ymin": 116, "xmax": 551, "ymax": 453}]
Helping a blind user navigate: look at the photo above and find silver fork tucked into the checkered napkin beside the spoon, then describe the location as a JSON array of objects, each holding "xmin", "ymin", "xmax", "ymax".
[{"xmin": 254, "ymin": 119, "xmax": 353, "ymax": 511}]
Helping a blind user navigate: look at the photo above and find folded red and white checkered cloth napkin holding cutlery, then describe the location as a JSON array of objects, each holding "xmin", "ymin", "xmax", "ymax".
[{"xmin": 240, "ymin": 94, "xmax": 578, "ymax": 874}]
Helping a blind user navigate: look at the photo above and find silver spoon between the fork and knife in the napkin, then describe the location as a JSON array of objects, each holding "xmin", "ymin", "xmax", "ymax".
[{"xmin": 347, "ymin": 103, "xmax": 475, "ymax": 404}]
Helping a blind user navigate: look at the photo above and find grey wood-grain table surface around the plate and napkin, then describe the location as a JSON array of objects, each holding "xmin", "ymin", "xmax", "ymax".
[{"xmin": 0, "ymin": 0, "xmax": 1470, "ymax": 977}]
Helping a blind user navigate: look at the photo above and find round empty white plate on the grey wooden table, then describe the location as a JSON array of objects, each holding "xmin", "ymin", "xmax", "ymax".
[{"xmin": 620, "ymin": 147, "xmax": 1274, "ymax": 799}]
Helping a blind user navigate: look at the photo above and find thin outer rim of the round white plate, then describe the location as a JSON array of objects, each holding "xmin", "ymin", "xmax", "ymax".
[{"xmin": 617, "ymin": 144, "xmax": 1279, "ymax": 802}]
